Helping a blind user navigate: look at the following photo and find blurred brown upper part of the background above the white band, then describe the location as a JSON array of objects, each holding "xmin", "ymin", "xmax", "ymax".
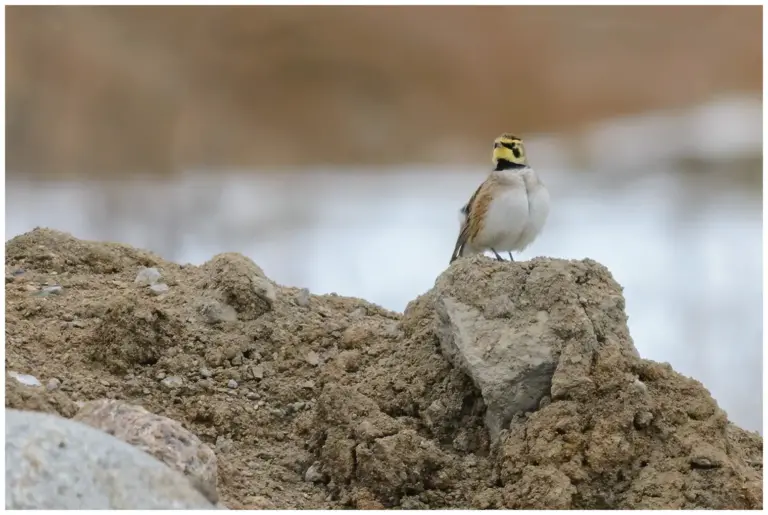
[{"xmin": 6, "ymin": 6, "xmax": 762, "ymax": 178}]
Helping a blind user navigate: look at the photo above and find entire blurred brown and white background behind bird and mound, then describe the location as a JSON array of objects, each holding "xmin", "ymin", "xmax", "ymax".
[{"xmin": 5, "ymin": 6, "xmax": 763, "ymax": 431}]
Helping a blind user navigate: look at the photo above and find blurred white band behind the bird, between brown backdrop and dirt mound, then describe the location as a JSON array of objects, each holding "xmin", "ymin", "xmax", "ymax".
[{"xmin": 6, "ymin": 94, "xmax": 762, "ymax": 430}]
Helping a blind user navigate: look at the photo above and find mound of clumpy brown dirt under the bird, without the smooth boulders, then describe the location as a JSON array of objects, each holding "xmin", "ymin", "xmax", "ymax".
[{"xmin": 6, "ymin": 229, "xmax": 762, "ymax": 509}]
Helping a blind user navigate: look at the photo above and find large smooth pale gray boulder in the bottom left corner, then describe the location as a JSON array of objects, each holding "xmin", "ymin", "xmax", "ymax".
[{"xmin": 5, "ymin": 409, "xmax": 215, "ymax": 510}]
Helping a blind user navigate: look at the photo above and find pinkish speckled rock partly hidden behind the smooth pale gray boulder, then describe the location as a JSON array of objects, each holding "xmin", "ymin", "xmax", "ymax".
[{"xmin": 73, "ymin": 399, "xmax": 218, "ymax": 503}]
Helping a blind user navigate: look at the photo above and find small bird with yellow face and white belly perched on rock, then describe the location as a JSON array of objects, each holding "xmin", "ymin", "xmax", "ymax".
[{"xmin": 450, "ymin": 133, "xmax": 549, "ymax": 263}]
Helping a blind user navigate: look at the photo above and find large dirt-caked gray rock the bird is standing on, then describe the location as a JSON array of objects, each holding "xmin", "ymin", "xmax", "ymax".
[{"xmin": 431, "ymin": 257, "xmax": 637, "ymax": 441}]
